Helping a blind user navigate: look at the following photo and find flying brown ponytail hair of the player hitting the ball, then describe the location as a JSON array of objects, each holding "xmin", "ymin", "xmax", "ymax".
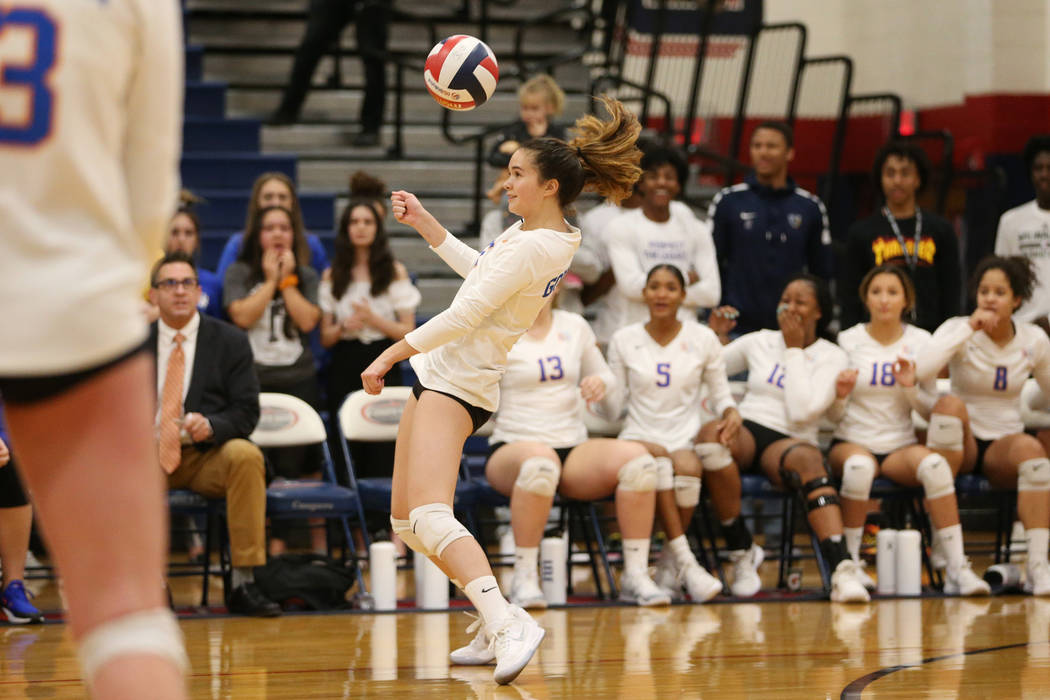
[{"xmin": 522, "ymin": 96, "xmax": 642, "ymax": 210}]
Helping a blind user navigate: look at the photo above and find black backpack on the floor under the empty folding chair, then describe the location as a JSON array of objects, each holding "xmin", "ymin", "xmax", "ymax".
[{"xmin": 255, "ymin": 554, "xmax": 357, "ymax": 610}]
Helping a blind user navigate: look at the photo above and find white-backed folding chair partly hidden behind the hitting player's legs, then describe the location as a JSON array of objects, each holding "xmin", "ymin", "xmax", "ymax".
[{"xmin": 336, "ymin": 386, "xmax": 478, "ymax": 544}]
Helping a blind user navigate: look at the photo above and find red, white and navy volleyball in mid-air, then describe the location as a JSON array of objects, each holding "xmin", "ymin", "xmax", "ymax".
[{"xmin": 423, "ymin": 34, "xmax": 500, "ymax": 111}]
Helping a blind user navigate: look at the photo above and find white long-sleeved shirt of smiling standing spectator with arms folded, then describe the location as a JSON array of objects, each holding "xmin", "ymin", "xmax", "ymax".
[{"xmin": 603, "ymin": 207, "xmax": 721, "ymax": 340}]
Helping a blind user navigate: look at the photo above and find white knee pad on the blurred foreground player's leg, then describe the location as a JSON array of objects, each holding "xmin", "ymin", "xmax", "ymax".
[{"xmin": 77, "ymin": 608, "xmax": 190, "ymax": 685}]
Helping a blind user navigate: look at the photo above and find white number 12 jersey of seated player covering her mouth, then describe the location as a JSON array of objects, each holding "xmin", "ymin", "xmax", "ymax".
[{"xmin": 725, "ymin": 331, "xmax": 848, "ymax": 442}]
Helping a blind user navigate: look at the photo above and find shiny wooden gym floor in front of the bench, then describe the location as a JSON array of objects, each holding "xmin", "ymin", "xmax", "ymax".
[{"xmin": 0, "ymin": 563, "xmax": 1050, "ymax": 700}]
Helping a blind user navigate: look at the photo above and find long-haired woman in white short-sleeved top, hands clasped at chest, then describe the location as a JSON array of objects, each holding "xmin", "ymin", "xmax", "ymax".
[{"xmin": 319, "ymin": 199, "xmax": 421, "ymax": 475}]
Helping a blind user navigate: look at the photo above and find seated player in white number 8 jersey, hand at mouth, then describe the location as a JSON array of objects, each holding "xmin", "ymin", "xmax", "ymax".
[{"xmin": 916, "ymin": 256, "xmax": 1050, "ymax": 596}]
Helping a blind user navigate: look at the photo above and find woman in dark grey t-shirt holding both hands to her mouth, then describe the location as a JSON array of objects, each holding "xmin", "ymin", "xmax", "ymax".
[{"xmin": 223, "ymin": 207, "xmax": 326, "ymax": 554}]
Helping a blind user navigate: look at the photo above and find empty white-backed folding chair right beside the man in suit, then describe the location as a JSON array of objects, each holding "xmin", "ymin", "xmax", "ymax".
[{"xmin": 251, "ymin": 393, "xmax": 368, "ymax": 593}]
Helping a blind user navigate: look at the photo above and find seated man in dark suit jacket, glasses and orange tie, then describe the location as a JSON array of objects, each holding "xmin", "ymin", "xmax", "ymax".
[{"xmin": 149, "ymin": 252, "xmax": 280, "ymax": 617}]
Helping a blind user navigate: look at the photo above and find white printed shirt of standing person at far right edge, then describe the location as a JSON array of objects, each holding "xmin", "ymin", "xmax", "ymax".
[{"xmin": 995, "ymin": 199, "xmax": 1050, "ymax": 321}]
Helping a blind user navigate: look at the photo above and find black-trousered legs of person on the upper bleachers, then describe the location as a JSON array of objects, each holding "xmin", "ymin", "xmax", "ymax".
[{"xmin": 270, "ymin": 0, "xmax": 392, "ymax": 146}]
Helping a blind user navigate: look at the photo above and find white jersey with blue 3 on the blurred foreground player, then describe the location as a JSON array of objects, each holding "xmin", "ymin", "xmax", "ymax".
[{"xmin": 0, "ymin": 0, "xmax": 184, "ymax": 376}]
